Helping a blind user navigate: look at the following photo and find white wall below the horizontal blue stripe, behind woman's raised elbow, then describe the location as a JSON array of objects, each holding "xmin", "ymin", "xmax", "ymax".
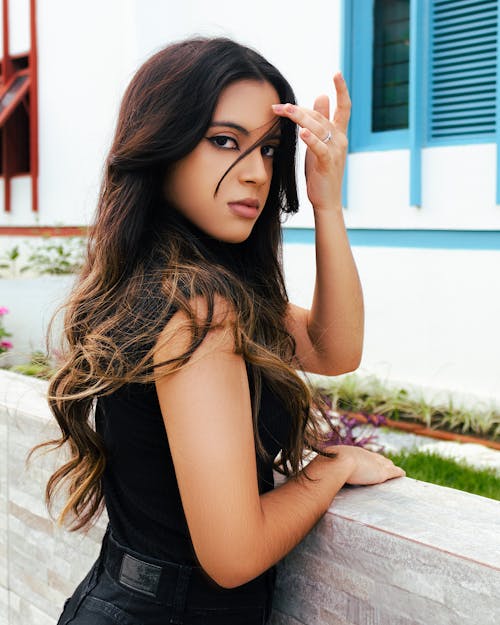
[{"xmin": 285, "ymin": 244, "xmax": 500, "ymax": 401}]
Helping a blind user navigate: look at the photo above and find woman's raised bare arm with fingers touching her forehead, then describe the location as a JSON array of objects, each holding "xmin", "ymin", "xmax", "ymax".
[{"xmin": 275, "ymin": 74, "xmax": 364, "ymax": 375}]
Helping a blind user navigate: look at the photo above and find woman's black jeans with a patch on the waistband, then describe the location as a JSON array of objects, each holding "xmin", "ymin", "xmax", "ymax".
[{"xmin": 57, "ymin": 527, "xmax": 276, "ymax": 625}]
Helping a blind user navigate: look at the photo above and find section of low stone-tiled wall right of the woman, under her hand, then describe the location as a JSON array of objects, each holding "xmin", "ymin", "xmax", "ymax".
[{"xmin": 272, "ymin": 460, "xmax": 500, "ymax": 625}]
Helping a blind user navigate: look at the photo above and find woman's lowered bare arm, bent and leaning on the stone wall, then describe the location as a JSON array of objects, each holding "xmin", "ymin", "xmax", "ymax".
[{"xmin": 152, "ymin": 304, "xmax": 401, "ymax": 588}]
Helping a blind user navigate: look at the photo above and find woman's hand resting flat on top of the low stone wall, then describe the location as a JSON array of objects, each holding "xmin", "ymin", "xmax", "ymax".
[{"xmin": 327, "ymin": 445, "xmax": 406, "ymax": 486}]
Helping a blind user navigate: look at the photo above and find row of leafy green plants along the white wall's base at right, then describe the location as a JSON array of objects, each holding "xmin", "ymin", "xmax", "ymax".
[{"xmin": 320, "ymin": 374, "xmax": 500, "ymax": 440}]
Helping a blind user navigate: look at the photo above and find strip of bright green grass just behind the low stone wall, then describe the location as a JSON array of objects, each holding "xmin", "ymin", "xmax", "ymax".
[{"xmin": 384, "ymin": 450, "xmax": 500, "ymax": 501}]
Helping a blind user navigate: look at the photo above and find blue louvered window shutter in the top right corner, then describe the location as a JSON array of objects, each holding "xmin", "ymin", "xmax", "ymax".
[{"xmin": 428, "ymin": 0, "xmax": 499, "ymax": 142}]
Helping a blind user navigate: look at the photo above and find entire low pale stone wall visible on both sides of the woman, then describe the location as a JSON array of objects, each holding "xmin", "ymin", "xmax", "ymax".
[{"xmin": 0, "ymin": 372, "xmax": 500, "ymax": 625}]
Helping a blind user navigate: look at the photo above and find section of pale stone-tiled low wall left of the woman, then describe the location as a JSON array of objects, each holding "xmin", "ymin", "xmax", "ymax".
[{"xmin": 0, "ymin": 371, "xmax": 106, "ymax": 625}]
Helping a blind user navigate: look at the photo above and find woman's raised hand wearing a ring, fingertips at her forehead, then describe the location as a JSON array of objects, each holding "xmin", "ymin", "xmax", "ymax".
[{"xmin": 273, "ymin": 72, "xmax": 351, "ymax": 211}]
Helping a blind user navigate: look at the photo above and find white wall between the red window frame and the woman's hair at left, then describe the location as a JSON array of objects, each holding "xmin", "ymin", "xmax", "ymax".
[{"xmin": 33, "ymin": 0, "xmax": 135, "ymax": 225}]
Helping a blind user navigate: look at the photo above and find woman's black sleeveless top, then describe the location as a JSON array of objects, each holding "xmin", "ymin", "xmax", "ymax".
[{"xmin": 96, "ymin": 381, "xmax": 290, "ymax": 566}]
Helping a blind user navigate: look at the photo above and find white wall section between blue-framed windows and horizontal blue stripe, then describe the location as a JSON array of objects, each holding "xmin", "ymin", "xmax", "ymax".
[{"xmin": 346, "ymin": 143, "xmax": 500, "ymax": 230}]
